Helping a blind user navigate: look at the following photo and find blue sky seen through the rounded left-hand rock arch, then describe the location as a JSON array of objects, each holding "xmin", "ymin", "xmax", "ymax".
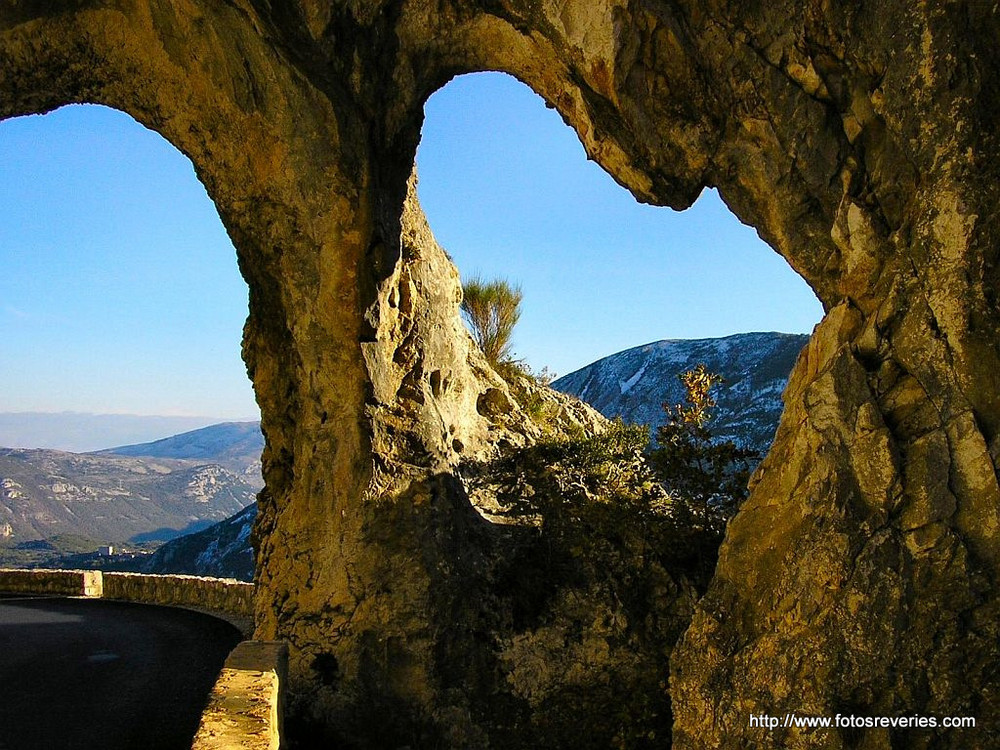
[{"xmin": 0, "ymin": 106, "xmax": 257, "ymax": 418}]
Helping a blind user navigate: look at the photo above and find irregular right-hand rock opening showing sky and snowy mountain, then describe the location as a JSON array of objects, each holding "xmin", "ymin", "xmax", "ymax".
[{"xmin": 417, "ymin": 73, "xmax": 822, "ymax": 464}]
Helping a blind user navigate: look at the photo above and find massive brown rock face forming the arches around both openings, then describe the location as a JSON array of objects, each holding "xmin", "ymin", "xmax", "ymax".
[{"xmin": 0, "ymin": 0, "xmax": 1000, "ymax": 747}]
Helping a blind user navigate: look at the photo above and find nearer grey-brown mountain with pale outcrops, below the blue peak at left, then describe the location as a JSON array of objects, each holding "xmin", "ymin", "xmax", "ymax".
[{"xmin": 0, "ymin": 448, "xmax": 256, "ymax": 546}]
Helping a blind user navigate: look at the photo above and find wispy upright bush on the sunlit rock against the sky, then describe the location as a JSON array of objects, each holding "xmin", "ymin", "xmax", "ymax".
[{"xmin": 462, "ymin": 277, "xmax": 524, "ymax": 367}]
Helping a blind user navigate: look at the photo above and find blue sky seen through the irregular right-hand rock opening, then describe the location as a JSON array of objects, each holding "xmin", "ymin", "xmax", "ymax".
[{"xmin": 417, "ymin": 74, "xmax": 822, "ymax": 382}]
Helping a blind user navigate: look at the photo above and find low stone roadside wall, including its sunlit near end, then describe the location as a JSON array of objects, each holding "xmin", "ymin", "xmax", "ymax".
[{"xmin": 0, "ymin": 568, "xmax": 288, "ymax": 750}]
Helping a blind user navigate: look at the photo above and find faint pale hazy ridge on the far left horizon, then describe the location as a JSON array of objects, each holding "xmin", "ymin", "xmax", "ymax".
[{"xmin": 0, "ymin": 412, "xmax": 245, "ymax": 453}]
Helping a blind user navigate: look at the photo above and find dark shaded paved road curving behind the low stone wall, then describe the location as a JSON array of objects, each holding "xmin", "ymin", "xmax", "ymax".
[{"xmin": 0, "ymin": 597, "xmax": 240, "ymax": 750}]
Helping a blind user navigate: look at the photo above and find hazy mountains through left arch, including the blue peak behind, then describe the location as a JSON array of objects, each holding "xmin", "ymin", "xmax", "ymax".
[{"xmin": 0, "ymin": 422, "xmax": 263, "ymax": 562}]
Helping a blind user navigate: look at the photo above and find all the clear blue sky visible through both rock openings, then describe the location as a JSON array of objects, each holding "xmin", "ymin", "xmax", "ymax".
[{"xmin": 0, "ymin": 74, "xmax": 820, "ymax": 419}]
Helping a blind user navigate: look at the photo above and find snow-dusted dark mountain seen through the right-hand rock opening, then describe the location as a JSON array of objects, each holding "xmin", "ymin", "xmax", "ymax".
[{"xmin": 552, "ymin": 333, "xmax": 809, "ymax": 453}]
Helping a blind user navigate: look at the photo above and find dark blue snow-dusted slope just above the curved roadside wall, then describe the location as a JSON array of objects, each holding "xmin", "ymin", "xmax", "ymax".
[{"xmin": 139, "ymin": 503, "xmax": 257, "ymax": 581}]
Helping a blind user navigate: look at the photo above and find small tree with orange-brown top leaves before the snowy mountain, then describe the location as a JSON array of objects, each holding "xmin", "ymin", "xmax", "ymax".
[{"xmin": 649, "ymin": 365, "xmax": 760, "ymax": 532}]
